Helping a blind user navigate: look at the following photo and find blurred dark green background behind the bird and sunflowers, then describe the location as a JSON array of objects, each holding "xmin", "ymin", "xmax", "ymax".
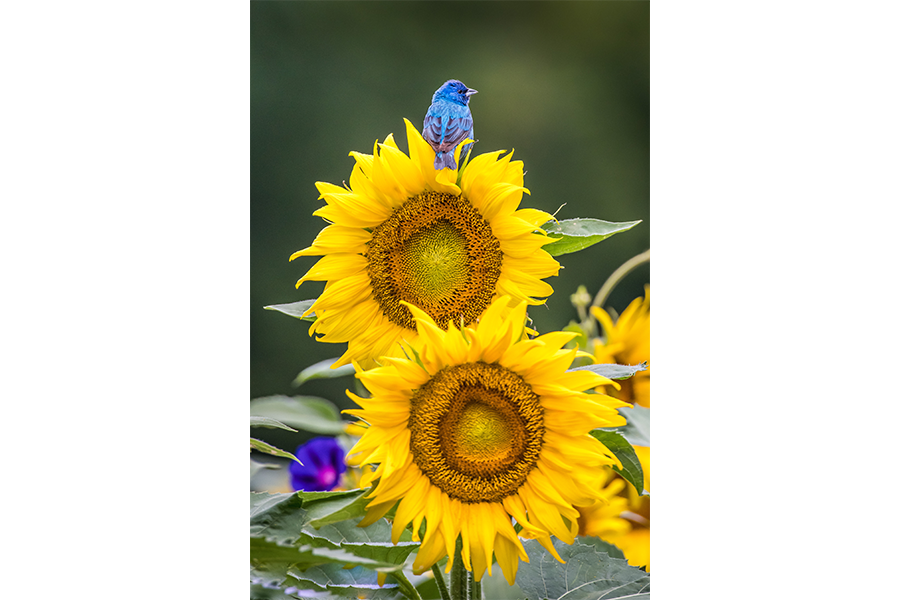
[{"xmin": 250, "ymin": 0, "xmax": 650, "ymax": 408}]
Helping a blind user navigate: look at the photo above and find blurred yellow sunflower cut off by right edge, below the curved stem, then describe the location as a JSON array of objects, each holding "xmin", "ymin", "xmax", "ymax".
[{"xmin": 591, "ymin": 286, "xmax": 650, "ymax": 408}]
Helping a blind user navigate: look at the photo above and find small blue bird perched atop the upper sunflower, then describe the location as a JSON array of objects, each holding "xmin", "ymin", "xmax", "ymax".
[{"xmin": 422, "ymin": 79, "xmax": 478, "ymax": 171}]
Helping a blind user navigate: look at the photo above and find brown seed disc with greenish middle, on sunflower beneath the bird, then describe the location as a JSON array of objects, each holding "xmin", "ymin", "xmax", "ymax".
[{"xmin": 366, "ymin": 192, "xmax": 503, "ymax": 329}]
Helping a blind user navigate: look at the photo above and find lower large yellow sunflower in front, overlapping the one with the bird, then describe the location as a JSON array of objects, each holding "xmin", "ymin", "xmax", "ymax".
[{"xmin": 346, "ymin": 296, "xmax": 627, "ymax": 584}]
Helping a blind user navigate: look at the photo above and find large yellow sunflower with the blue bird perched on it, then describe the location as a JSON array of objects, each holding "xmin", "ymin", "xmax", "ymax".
[{"xmin": 291, "ymin": 121, "xmax": 559, "ymax": 368}]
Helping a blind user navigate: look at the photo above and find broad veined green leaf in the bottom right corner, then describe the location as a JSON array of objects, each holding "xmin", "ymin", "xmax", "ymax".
[{"xmin": 516, "ymin": 538, "xmax": 650, "ymax": 600}]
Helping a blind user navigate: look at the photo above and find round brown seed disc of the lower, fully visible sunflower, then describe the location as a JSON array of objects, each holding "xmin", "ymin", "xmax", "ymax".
[{"xmin": 409, "ymin": 363, "xmax": 544, "ymax": 502}]
